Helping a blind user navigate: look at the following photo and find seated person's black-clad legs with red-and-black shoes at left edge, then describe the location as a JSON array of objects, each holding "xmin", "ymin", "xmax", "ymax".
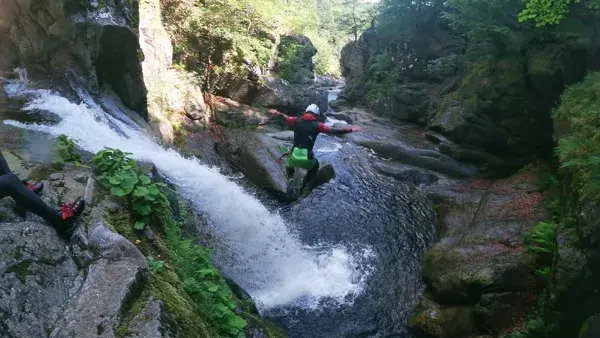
[{"xmin": 0, "ymin": 151, "xmax": 85, "ymax": 240}]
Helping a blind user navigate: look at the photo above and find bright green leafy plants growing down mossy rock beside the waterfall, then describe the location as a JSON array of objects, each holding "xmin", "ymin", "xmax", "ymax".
[{"xmin": 94, "ymin": 148, "xmax": 247, "ymax": 338}]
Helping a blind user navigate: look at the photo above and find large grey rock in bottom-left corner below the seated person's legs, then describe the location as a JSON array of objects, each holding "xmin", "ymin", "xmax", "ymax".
[{"xmin": 0, "ymin": 222, "xmax": 82, "ymax": 337}]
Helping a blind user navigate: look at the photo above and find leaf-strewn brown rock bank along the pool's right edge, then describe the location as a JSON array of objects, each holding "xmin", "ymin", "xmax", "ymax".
[{"xmin": 411, "ymin": 172, "xmax": 545, "ymax": 337}]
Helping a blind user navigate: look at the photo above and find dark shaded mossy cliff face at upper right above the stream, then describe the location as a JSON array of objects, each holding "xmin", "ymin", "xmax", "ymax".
[{"xmin": 341, "ymin": 8, "xmax": 598, "ymax": 175}]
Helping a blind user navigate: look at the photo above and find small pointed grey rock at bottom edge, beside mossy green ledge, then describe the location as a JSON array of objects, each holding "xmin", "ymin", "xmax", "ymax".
[{"xmin": 127, "ymin": 297, "xmax": 181, "ymax": 338}]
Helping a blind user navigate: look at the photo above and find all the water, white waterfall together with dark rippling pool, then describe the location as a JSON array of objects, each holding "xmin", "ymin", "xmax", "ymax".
[{"xmin": 2, "ymin": 70, "xmax": 433, "ymax": 337}]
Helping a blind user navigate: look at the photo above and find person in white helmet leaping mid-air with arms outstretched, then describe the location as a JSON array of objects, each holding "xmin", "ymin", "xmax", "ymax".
[{"xmin": 268, "ymin": 104, "xmax": 362, "ymax": 190}]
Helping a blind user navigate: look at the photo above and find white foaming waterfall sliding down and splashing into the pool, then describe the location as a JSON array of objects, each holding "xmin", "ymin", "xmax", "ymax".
[{"xmin": 0, "ymin": 73, "xmax": 369, "ymax": 310}]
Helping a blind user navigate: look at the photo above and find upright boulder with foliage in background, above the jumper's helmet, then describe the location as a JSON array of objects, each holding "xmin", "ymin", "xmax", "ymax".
[{"xmin": 273, "ymin": 35, "xmax": 317, "ymax": 84}]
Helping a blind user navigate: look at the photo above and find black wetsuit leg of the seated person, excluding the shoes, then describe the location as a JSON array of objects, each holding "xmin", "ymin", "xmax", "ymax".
[{"xmin": 0, "ymin": 152, "xmax": 65, "ymax": 227}]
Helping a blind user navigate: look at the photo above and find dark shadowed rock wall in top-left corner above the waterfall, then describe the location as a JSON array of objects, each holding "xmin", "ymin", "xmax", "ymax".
[{"xmin": 0, "ymin": 0, "xmax": 146, "ymax": 113}]
